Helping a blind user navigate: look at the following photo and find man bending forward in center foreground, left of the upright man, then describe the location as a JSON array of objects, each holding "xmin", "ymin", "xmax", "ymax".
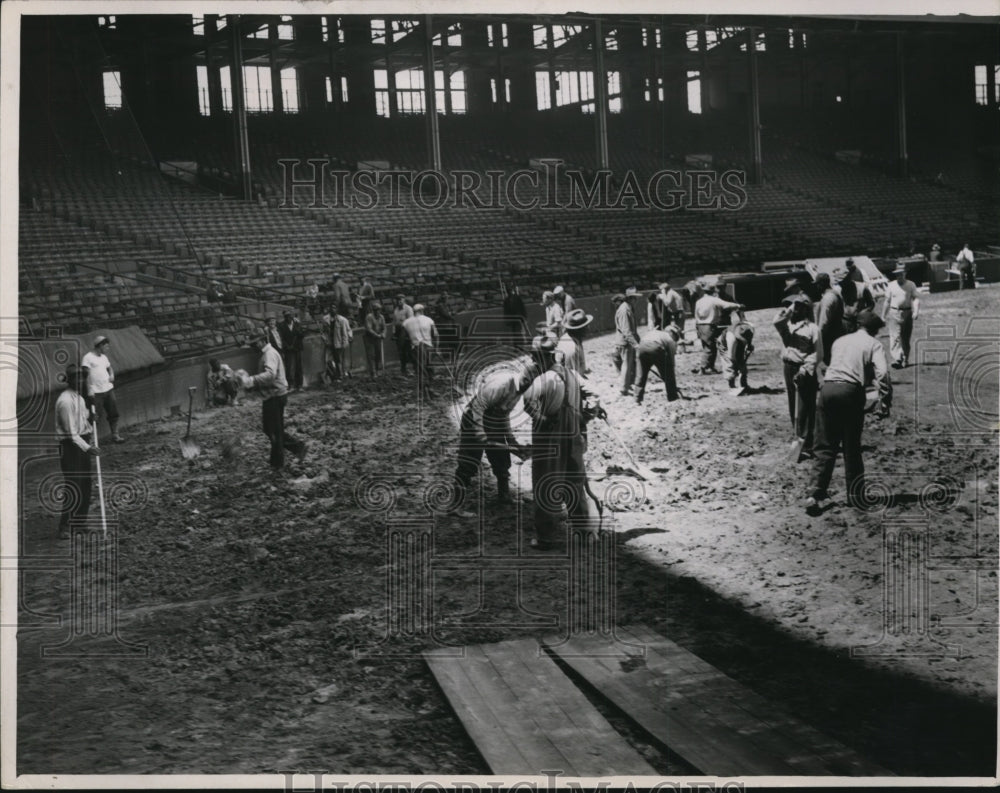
[{"xmin": 455, "ymin": 358, "xmax": 542, "ymax": 510}]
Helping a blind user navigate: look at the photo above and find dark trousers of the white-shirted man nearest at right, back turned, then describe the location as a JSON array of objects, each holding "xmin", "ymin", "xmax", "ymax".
[{"xmin": 810, "ymin": 380, "xmax": 865, "ymax": 500}]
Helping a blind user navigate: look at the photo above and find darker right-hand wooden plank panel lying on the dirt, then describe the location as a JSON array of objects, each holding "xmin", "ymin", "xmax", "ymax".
[{"xmin": 549, "ymin": 625, "xmax": 891, "ymax": 776}]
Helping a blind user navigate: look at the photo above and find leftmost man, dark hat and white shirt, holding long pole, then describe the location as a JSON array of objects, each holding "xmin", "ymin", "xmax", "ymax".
[{"xmin": 56, "ymin": 364, "xmax": 101, "ymax": 540}]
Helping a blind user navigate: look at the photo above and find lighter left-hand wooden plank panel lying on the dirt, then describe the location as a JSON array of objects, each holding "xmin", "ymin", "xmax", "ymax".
[{"xmin": 424, "ymin": 639, "xmax": 657, "ymax": 776}]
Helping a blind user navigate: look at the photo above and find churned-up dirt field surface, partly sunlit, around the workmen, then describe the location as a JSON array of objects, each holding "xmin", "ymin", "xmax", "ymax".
[{"xmin": 17, "ymin": 289, "xmax": 1000, "ymax": 776}]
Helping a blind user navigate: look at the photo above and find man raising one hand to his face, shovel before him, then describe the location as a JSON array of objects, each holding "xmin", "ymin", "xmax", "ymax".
[{"xmin": 774, "ymin": 294, "xmax": 822, "ymax": 455}]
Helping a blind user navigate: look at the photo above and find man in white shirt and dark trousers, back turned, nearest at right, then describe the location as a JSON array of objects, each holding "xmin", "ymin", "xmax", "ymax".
[{"xmin": 806, "ymin": 311, "xmax": 892, "ymax": 516}]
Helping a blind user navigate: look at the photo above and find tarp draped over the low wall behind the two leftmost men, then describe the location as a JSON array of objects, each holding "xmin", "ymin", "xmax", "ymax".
[{"xmin": 17, "ymin": 325, "xmax": 164, "ymax": 400}]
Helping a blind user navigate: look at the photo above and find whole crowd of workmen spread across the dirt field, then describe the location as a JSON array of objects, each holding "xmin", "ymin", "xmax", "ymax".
[{"xmin": 56, "ymin": 252, "xmax": 952, "ymax": 549}]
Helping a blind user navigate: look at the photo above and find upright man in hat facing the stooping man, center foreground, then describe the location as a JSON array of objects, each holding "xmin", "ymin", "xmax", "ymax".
[{"xmin": 523, "ymin": 336, "xmax": 607, "ymax": 550}]
